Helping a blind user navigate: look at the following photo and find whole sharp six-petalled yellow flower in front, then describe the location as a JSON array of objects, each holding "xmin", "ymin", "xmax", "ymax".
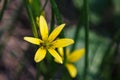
[{"xmin": 24, "ymin": 16, "xmax": 74, "ymax": 63}]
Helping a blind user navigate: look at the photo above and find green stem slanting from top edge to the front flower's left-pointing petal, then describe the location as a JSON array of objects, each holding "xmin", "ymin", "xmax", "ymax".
[{"xmin": 25, "ymin": 0, "xmax": 38, "ymax": 37}]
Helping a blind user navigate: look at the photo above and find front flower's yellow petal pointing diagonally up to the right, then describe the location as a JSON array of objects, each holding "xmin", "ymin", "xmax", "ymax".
[{"xmin": 48, "ymin": 24, "xmax": 65, "ymax": 42}]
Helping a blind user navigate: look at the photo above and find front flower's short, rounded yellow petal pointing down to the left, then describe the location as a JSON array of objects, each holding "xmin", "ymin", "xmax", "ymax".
[{"xmin": 34, "ymin": 48, "xmax": 46, "ymax": 62}]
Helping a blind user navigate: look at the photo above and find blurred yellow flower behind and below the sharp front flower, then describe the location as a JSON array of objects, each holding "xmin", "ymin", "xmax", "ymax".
[{"xmin": 55, "ymin": 48, "xmax": 85, "ymax": 78}]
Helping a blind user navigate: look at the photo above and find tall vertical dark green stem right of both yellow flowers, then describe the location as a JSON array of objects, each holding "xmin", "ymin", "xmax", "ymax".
[{"xmin": 83, "ymin": 0, "xmax": 89, "ymax": 80}]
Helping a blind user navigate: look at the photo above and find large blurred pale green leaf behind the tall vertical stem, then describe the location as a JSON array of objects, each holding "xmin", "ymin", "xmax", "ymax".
[{"xmin": 66, "ymin": 26, "xmax": 110, "ymax": 80}]
